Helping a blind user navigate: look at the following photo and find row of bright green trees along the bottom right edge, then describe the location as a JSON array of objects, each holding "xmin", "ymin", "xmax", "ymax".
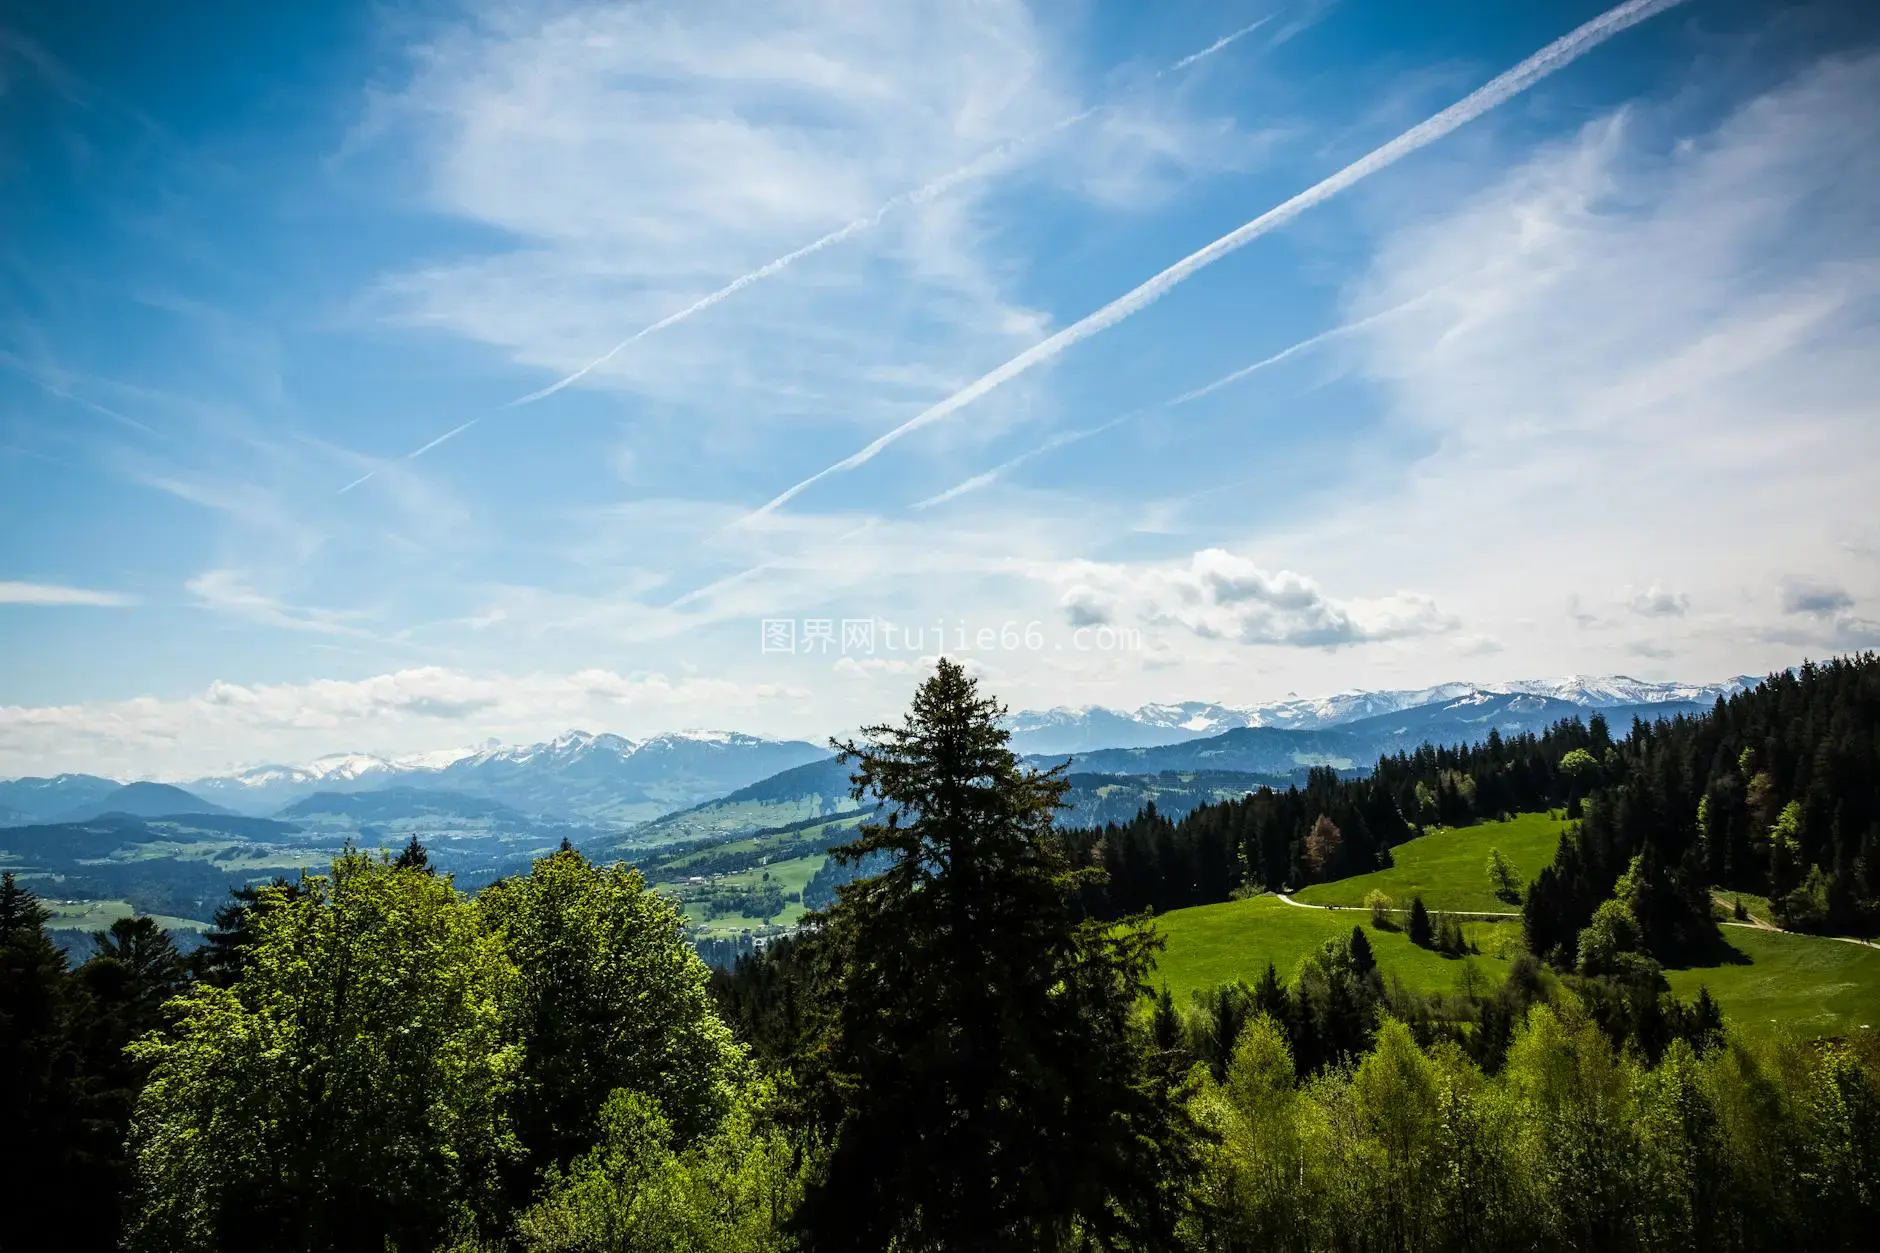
[{"xmin": 1186, "ymin": 1003, "xmax": 1880, "ymax": 1253}]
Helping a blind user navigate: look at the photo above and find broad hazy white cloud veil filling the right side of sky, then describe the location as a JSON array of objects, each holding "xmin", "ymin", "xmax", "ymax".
[{"xmin": 1284, "ymin": 43, "xmax": 1880, "ymax": 674}]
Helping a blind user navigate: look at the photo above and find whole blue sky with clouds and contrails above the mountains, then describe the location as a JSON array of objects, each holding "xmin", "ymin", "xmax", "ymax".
[{"xmin": 0, "ymin": 0, "xmax": 1880, "ymax": 779}]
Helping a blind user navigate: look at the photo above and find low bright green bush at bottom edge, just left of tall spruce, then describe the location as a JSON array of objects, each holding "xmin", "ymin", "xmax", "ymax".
[{"xmin": 515, "ymin": 1087, "xmax": 803, "ymax": 1253}]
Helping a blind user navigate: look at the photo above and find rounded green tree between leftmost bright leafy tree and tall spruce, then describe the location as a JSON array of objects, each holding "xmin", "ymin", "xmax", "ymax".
[{"xmin": 478, "ymin": 849, "xmax": 744, "ymax": 1183}]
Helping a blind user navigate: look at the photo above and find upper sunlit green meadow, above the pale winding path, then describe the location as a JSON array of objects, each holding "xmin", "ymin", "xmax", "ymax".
[{"xmin": 1293, "ymin": 813, "xmax": 1566, "ymax": 912}]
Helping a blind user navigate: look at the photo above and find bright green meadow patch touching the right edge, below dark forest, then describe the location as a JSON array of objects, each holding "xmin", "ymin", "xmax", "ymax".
[{"xmin": 1664, "ymin": 921, "xmax": 1880, "ymax": 1037}]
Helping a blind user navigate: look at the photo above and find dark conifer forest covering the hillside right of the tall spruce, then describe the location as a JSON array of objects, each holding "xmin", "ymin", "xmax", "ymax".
[{"xmin": 1070, "ymin": 653, "xmax": 1880, "ymax": 940}]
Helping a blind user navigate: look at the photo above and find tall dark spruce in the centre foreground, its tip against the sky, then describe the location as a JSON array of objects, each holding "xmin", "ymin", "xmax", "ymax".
[{"xmin": 799, "ymin": 658, "xmax": 1192, "ymax": 1251}]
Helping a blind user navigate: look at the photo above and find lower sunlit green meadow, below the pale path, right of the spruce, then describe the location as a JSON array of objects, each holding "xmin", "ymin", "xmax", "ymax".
[{"xmin": 1151, "ymin": 896, "xmax": 1521, "ymax": 1001}]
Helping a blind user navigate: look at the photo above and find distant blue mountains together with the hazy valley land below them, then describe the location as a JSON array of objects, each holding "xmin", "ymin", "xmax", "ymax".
[{"xmin": 0, "ymin": 662, "xmax": 1750, "ymax": 920}]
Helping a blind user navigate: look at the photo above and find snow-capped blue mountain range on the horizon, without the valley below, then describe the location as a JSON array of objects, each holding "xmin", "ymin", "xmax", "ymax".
[{"xmin": 0, "ymin": 675, "xmax": 1754, "ymax": 845}]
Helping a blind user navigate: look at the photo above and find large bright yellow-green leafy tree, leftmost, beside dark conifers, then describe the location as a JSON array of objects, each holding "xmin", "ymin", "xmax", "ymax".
[{"xmin": 132, "ymin": 850, "xmax": 519, "ymax": 1249}]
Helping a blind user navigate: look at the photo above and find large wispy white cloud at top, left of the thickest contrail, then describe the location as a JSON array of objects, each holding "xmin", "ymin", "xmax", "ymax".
[{"xmin": 362, "ymin": 0, "xmax": 1083, "ymax": 460}]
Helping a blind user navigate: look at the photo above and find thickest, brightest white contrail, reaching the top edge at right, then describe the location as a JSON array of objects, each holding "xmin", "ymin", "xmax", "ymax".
[{"xmin": 744, "ymin": 0, "xmax": 1683, "ymax": 521}]
